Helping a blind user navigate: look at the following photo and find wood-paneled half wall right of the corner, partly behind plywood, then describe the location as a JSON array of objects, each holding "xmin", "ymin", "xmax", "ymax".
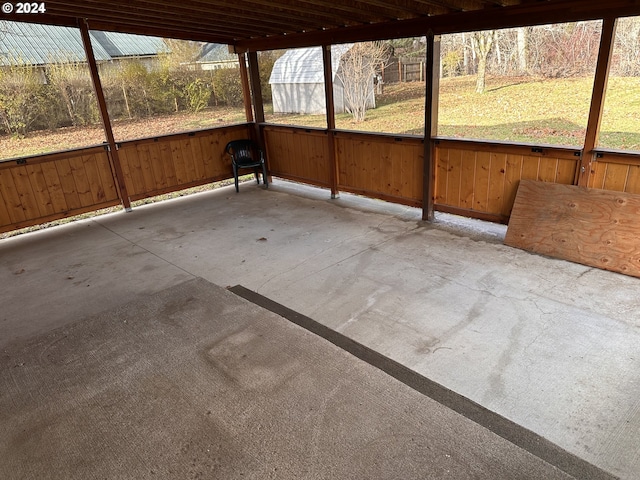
[{"xmin": 263, "ymin": 125, "xmax": 640, "ymax": 223}]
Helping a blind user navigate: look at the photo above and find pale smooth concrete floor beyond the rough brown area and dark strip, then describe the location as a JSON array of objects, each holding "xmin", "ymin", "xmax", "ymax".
[{"xmin": 0, "ymin": 180, "xmax": 640, "ymax": 479}]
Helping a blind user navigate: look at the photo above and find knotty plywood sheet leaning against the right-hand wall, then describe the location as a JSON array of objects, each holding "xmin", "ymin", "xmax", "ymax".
[{"xmin": 504, "ymin": 180, "xmax": 640, "ymax": 277}]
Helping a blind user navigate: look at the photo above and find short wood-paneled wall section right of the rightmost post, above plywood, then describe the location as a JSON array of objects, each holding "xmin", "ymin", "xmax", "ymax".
[{"xmin": 588, "ymin": 153, "xmax": 640, "ymax": 193}]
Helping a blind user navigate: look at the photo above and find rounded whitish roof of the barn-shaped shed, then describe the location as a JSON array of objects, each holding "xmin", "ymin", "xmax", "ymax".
[{"xmin": 269, "ymin": 43, "xmax": 353, "ymax": 85}]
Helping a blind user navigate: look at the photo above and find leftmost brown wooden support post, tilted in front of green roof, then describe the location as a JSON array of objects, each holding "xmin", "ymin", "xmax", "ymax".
[{"xmin": 79, "ymin": 19, "xmax": 131, "ymax": 212}]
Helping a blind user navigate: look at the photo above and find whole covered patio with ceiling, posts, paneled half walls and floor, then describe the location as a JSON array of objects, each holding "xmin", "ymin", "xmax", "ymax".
[{"xmin": 0, "ymin": 0, "xmax": 640, "ymax": 480}]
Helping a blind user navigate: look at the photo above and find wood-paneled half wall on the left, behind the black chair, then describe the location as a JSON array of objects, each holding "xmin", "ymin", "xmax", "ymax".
[{"xmin": 0, "ymin": 124, "xmax": 249, "ymax": 232}]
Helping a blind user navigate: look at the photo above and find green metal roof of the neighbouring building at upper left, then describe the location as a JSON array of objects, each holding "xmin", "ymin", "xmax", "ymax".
[{"xmin": 0, "ymin": 20, "xmax": 165, "ymax": 65}]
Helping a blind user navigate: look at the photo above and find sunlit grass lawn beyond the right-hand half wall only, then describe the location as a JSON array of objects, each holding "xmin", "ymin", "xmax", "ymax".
[{"xmin": 267, "ymin": 77, "xmax": 640, "ymax": 150}]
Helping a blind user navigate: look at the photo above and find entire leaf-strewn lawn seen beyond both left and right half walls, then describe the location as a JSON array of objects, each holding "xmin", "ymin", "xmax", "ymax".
[{"xmin": 0, "ymin": 77, "xmax": 640, "ymax": 158}]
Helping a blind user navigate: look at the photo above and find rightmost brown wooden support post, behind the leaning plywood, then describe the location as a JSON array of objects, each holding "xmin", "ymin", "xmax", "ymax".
[{"xmin": 576, "ymin": 17, "xmax": 617, "ymax": 187}]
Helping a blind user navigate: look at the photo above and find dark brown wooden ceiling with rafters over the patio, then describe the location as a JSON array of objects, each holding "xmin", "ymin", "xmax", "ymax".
[{"xmin": 2, "ymin": 0, "xmax": 640, "ymax": 51}]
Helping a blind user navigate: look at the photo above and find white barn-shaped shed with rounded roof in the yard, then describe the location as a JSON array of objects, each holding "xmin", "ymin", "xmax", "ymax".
[{"xmin": 269, "ymin": 44, "xmax": 375, "ymax": 115}]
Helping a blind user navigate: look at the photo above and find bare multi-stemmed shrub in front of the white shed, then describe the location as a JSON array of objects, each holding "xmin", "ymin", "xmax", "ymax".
[{"xmin": 337, "ymin": 42, "xmax": 389, "ymax": 122}]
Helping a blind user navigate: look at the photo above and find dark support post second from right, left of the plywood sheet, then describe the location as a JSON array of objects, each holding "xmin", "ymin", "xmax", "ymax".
[{"xmin": 422, "ymin": 31, "xmax": 440, "ymax": 222}]
